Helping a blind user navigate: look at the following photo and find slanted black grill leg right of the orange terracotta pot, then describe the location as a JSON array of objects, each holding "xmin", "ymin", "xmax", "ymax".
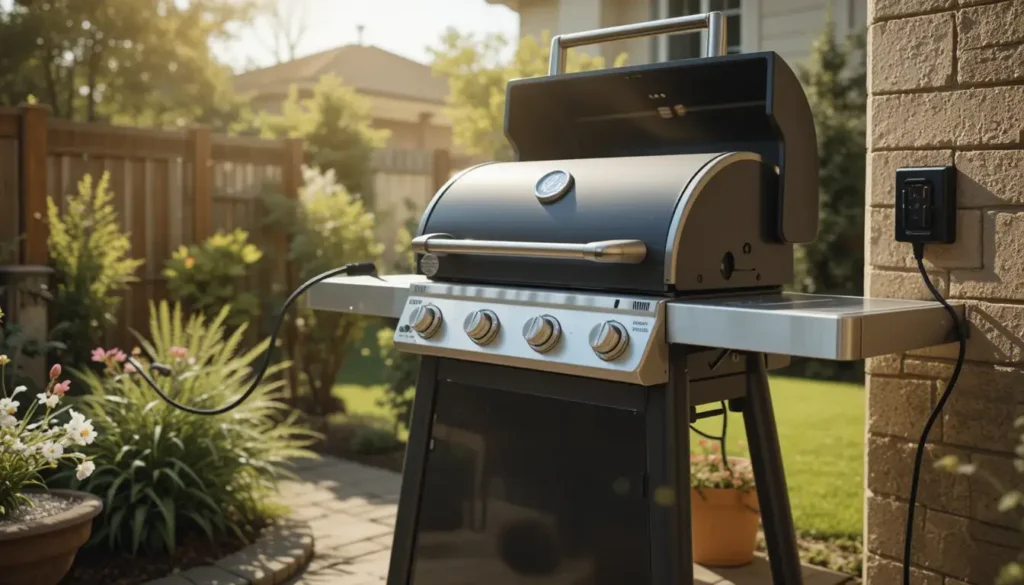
[{"xmin": 743, "ymin": 353, "xmax": 803, "ymax": 585}]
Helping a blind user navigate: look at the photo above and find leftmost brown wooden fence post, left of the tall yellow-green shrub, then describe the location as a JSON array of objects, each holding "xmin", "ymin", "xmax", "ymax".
[{"xmin": 18, "ymin": 105, "xmax": 49, "ymax": 265}]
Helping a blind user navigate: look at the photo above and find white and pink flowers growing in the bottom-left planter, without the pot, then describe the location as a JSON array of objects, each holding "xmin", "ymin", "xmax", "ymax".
[{"xmin": 0, "ymin": 356, "xmax": 96, "ymax": 518}]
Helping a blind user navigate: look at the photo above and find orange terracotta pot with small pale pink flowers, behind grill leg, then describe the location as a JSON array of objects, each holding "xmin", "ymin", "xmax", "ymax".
[{"xmin": 690, "ymin": 441, "xmax": 761, "ymax": 567}]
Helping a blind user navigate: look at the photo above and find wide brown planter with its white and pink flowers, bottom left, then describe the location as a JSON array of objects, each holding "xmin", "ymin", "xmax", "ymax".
[{"xmin": 0, "ymin": 348, "xmax": 102, "ymax": 585}]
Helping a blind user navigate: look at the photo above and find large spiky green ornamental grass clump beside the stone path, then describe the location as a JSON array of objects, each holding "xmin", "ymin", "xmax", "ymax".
[{"xmin": 50, "ymin": 301, "xmax": 315, "ymax": 554}]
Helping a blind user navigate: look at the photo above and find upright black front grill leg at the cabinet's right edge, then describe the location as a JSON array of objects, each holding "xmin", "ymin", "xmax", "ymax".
[{"xmin": 646, "ymin": 345, "xmax": 693, "ymax": 585}]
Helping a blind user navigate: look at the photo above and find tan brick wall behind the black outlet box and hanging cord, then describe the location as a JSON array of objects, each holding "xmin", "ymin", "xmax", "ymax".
[{"xmin": 865, "ymin": 0, "xmax": 1024, "ymax": 585}]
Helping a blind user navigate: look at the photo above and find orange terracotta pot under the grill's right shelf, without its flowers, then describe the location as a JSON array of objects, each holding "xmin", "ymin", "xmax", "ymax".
[{"xmin": 690, "ymin": 489, "xmax": 761, "ymax": 567}]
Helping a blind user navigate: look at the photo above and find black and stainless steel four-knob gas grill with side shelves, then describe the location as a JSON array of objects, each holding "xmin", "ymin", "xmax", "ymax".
[{"xmin": 308, "ymin": 12, "xmax": 962, "ymax": 585}]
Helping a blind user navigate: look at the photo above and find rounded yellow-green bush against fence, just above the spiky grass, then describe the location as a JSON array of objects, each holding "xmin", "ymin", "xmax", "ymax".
[{"xmin": 164, "ymin": 229, "xmax": 263, "ymax": 327}]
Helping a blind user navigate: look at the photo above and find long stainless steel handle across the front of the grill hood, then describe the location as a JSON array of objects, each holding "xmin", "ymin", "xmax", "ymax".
[{"xmin": 412, "ymin": 234, "xmax": 647, "ymax": 264}]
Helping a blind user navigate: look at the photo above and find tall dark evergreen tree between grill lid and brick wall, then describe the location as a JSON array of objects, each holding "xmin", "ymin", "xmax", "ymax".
[{"xmin": 796, "ymin": 20, "xmax": 867, "ymax": 294}]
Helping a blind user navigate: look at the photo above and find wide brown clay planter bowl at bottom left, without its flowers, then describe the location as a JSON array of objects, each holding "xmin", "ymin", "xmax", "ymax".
[{"xmin": 0, "ymin": 490, "xmax": 103, "ymax": 585}]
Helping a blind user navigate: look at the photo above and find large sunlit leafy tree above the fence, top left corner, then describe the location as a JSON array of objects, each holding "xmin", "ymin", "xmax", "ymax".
[{"xmin": 0, "ymin": 0, "xmax": 255, "ymax": 127}]
